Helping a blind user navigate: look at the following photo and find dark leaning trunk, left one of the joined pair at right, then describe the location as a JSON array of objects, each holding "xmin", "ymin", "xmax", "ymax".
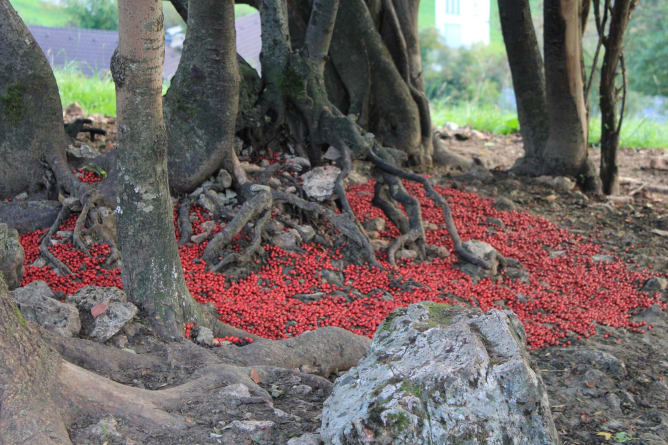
[{"xmin": 498, "ymin": 0, "xmax": 549, "ymax": 168}]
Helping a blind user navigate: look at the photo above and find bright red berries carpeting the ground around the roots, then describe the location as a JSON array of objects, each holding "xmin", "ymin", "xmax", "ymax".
[{"xmin": 21, "ymin": 182, "xmax": 665, "ymax": 349}]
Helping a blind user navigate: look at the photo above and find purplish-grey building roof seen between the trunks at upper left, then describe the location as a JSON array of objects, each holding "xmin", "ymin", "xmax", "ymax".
[{"xmin": 28, "ymin": 14, "xmax": 262, "ymax": 79}]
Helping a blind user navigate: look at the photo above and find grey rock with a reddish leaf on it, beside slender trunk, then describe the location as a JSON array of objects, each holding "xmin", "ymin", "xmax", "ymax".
[{"xmin": 67, "ymin": 286, "xmax": 138, "ymax": 342}]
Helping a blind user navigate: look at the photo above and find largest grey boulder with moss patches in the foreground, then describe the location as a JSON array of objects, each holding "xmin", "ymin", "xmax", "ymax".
[{"xmin": 321, "ymin": 302, "xmax": 559, "ymax": 445}]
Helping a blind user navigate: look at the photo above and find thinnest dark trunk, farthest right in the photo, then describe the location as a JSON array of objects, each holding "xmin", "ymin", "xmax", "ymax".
[{"xmin": 597, "ymin": 0, "xmax": 636, "ymax": 195}]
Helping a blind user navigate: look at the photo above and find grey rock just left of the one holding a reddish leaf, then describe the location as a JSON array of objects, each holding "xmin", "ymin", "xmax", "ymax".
[{"xmin": 11, "ymin": 281, "xmax": 81, "ymax": 337}]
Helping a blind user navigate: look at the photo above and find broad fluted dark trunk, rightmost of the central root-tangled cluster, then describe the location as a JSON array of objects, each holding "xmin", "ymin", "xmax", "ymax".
[{"xmin": 286, "ymin": 0, "xmax": 432, "ymax": 165}]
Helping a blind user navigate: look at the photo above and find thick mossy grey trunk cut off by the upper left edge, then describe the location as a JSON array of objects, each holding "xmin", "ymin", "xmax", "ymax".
[{"xmin": 0, "ymin": 0, "xmax": 82, "ymax": 199}]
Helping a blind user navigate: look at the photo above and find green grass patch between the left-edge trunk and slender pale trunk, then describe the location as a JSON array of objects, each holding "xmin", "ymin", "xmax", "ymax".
[{"xmin": 54, "ymin": 66, "xmax": 116, "ymax": 116}]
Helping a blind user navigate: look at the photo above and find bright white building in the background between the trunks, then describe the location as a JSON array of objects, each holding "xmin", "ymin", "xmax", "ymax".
[{"xmin": 436, "ymin": 0, "xmax": 490, "ymax": 48}]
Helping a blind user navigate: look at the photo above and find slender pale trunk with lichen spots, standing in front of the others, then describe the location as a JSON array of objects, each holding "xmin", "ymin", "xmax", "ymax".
[{"xmin": 111, "ymin": 0, "xmax": 204, "ymax": 338}]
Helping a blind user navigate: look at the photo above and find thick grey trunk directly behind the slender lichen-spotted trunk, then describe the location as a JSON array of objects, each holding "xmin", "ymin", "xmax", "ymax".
[{"xmin": 164, "ymin": 0, "xmax": 245, "ymax": 192}]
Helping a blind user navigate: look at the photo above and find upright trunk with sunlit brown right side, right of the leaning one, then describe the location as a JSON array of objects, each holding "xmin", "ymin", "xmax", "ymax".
[{"xmin": 542, "ymin": 0, "xmax": 595, "ymax": 189}]
